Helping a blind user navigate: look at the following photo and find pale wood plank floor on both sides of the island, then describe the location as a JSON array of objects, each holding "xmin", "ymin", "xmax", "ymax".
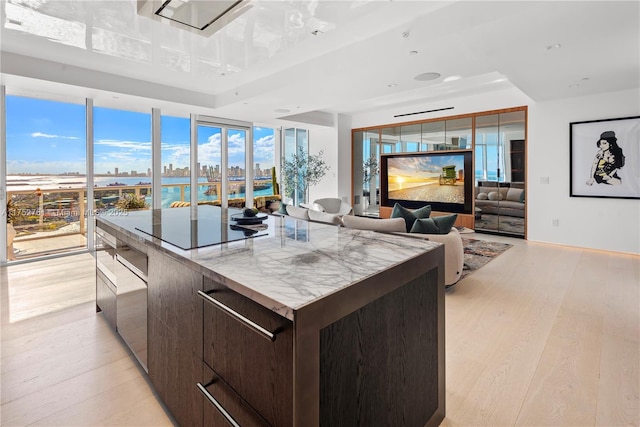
[{"xmin": 0, "ymin": 234, "xmax": 640, "ymax": 426}]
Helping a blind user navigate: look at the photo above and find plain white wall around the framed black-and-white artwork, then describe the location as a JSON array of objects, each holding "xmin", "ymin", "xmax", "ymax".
[{"xmin": 527, "ymin": 90, "xmax": 640, "ymax": 254}]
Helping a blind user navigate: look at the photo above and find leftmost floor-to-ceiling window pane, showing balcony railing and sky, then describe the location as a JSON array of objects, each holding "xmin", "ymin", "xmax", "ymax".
[{"xmin": 3, "ymin": 95, "xmax": 87, "ymax": 260}]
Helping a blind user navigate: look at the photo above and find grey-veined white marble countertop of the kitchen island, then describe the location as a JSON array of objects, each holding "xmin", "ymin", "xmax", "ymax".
[{"xmin": 98, "ymin": 206, "xmax": 440, "ymax": 319}]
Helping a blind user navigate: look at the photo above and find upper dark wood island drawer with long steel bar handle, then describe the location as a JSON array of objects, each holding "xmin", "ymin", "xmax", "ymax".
[{"xmin": 203, "ymin": 279, "xmax": 293, "ymax": 426}]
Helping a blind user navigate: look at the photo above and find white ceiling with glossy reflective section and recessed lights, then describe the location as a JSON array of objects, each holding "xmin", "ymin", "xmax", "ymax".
[{"xmin": 0, "ymin": 0, "xmax": 640, "ymax": 123}]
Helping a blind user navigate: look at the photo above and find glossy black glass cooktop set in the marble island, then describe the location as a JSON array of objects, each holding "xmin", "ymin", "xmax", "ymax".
[{"xmin": 135, "ymin": 206, "xmax": 268, "ymax": 250}]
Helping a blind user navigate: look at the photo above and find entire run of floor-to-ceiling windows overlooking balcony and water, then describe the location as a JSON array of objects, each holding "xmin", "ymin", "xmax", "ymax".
[{"xmin": 0, "ymin": 91, "xmax": 278, "ymax": 261}]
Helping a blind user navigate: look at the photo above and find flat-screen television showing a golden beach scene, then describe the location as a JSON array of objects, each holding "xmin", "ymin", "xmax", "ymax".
[{"xmin": 380, "ymin": 151, "xmax": 473, "ymax": 214}]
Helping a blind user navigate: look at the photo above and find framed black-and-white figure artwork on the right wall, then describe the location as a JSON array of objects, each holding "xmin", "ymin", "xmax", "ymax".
[{"xmin": 569, "ymin": 116, "xmax": 640, "ymax": 199}]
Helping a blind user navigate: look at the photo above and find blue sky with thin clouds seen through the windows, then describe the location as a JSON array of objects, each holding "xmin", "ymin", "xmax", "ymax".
[{"xmin": 6, "ymin": 96, "xmax": 275, "ymax": 175}]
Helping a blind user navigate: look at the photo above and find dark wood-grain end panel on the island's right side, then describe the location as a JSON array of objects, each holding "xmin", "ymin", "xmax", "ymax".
[{"xmin": 319, "ymin": 270, "xmax": 444, "ymax": 427}]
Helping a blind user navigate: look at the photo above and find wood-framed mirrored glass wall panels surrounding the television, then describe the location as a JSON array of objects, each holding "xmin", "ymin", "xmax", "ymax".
[{"xmin": 352, "ymin": 107, "xmax": 527, "ymax": 236}]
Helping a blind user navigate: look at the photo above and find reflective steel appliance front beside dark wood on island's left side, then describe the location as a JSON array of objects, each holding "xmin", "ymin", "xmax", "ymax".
[{"xmin": 116, "ymin": 241, "xmax": 148, "ymax": 372}]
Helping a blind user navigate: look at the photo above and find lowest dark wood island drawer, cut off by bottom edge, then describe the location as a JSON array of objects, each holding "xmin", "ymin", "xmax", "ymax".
[{"xmin": 197, "ymin": 365, "xmax": 269, "ymax": 427}]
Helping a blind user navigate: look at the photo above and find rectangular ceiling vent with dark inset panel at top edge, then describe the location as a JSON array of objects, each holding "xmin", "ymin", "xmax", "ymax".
[{"xmin": 138, "ymin": 0, "xmax": 252, "ymax": 36}]
